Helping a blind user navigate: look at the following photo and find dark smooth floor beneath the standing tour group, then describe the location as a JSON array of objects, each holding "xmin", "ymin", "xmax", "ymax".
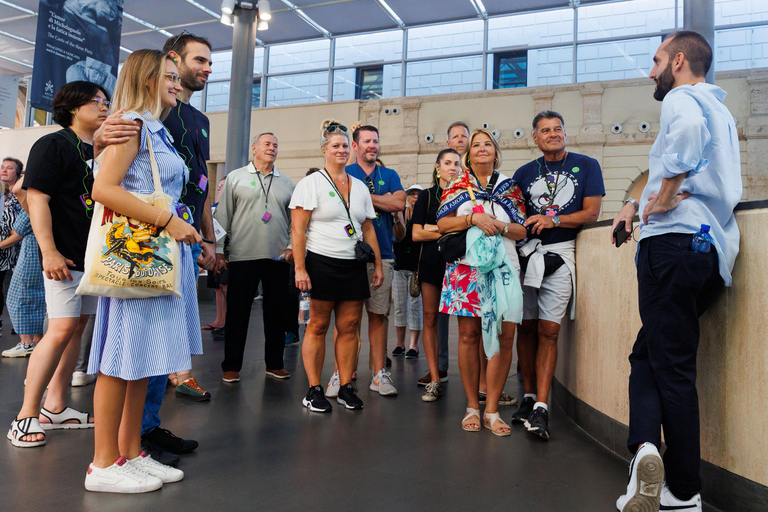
[{"xmin": 0, "ymin": 302, "xmax": 644, "ymax": 512}]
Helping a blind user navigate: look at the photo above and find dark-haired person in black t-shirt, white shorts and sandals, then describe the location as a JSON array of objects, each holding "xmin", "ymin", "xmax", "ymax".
[{"xmin": 8, "ymin": 81, "xmax": 109, "ymax": 448}]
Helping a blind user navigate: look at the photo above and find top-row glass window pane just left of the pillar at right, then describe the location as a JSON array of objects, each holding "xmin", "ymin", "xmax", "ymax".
[{"xmin": 578, "ymin": 0, "xmax": 675, "ymax": 41}]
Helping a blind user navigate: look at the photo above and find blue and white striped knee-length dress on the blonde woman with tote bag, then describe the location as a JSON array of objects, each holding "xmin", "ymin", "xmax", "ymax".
[{"xmin": 88, "ymin": 114, "xmax": 203, "ymax": 380}]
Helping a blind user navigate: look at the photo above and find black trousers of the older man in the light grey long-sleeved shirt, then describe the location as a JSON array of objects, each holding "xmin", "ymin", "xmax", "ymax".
[{"xmin": 221, "ymin": 259, "xmax": 289, "ymax": 372}]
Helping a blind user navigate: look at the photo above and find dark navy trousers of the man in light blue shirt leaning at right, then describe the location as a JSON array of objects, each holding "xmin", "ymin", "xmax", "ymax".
[{"xmin": 627, "ymin": 233, "xmax": 723, "ymax": 494}]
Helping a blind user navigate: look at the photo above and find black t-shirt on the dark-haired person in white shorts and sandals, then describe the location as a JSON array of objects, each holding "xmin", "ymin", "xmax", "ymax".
[{"xmin": 23, "ymin": 129, "xmax": 94, "ymax": 272}]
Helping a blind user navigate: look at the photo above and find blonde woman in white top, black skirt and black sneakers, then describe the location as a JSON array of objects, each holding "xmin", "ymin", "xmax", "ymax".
[{"xmin": 289, "ymin": 122, "xmax": 384, "ymax": 412}]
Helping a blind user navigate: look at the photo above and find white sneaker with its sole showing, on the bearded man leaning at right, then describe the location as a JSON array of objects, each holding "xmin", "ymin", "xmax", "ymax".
[{"xmin": 616, "ymin": 443, "xmax": 664, "ymax": 512}]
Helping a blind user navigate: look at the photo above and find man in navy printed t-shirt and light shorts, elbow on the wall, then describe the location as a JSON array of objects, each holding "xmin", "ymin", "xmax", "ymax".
[{"xmin": 512, "ymin": 110, "xmax": 605, "ymax": 439}]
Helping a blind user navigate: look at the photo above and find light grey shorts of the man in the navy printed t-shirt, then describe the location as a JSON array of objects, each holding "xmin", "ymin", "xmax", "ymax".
[{"xmin": 523, "ymin": 265, "xmax": 573, "ymax": 324}]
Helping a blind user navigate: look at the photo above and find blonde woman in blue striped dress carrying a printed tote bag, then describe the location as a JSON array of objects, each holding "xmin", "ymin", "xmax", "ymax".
[{"xmin": 85, "ymin": 50, "xmax": 202, "ymax": 493}]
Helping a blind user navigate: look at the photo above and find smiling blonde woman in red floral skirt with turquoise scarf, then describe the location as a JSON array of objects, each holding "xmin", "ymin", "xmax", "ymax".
[{"xmin": 437, "ymin": 129, "xmax": 526, "ymax": 436}]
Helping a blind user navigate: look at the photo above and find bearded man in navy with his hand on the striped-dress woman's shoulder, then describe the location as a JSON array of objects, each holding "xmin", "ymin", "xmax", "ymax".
[{"xmin": 95, "ymin": 33, "xmax": 216, "ymax": 465}]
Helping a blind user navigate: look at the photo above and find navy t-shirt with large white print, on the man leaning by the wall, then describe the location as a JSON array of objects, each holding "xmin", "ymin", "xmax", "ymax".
[{"xmin": 512, "ymin": 152, "xmax": 605, "ymax": 245}]
